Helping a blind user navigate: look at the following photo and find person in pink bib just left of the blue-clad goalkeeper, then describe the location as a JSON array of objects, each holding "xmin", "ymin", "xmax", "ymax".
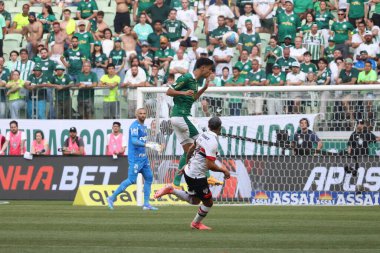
[{"xmin": 106, "ymin": 121, "xmax": 127, "ymax": 156}]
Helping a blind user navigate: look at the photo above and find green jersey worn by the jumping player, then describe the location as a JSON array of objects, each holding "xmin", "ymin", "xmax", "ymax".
[{"xmin": 170, "ymin": 73, "xmax": 199, "ymax": 117}]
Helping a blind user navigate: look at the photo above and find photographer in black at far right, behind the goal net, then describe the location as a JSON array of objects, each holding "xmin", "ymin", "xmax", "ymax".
[{"xmin": 347, "ymin": 119, "xmax": 380, "ymax": 156}]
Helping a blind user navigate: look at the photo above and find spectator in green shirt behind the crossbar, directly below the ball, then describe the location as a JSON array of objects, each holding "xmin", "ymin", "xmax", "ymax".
[{"xmin": 224, "ymin": 67, "xmax": 245, "ymax": 116}]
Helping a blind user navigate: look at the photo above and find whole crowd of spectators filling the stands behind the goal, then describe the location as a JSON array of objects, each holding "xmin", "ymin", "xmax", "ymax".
[{"xmin": 0, "ymin": 0, "xmax": 380, "ymax": 120}]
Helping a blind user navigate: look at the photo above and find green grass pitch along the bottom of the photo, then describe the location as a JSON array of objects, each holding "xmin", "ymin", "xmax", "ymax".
[{"xmin": 0, "ymin": 201, "xmax": 380, "ymax": 253}]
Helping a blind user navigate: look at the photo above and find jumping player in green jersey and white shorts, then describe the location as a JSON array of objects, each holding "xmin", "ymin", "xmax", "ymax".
[{"xmin": 166, "ymin": 58, "xmax": 222, "ymax": 188}]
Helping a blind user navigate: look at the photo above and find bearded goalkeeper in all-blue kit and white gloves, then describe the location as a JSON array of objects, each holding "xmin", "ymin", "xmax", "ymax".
[{"xmin": 107, "ymin": 108, "xmax": 161, "ymax": 211}]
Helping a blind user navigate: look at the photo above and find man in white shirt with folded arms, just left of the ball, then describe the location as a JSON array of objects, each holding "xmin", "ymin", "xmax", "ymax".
[{"xmin": 212, "ymin": 39, "xmax": 234, "ymax": 77}]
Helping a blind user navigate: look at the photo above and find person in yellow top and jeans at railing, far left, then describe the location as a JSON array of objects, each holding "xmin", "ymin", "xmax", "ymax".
[{"xmin": 5, "ymin": 70, "xmax": 25, "ymax": 119}]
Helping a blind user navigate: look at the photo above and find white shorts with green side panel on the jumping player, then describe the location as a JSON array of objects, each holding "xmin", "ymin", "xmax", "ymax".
[{"xmin": 170, "ymin": 117, "xmax": 202, "ymax": 145}]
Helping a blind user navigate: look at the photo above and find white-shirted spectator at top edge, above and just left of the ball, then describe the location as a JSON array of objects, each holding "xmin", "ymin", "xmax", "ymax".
[{"xmin": 204, "ymin": 0, "xmax": 234, "ymax": 35}]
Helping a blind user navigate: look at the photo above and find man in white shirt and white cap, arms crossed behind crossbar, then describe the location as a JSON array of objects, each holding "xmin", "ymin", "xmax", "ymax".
[{"xmin": 286, "ymin": 62, "xmax": 306, "ymax": 114}]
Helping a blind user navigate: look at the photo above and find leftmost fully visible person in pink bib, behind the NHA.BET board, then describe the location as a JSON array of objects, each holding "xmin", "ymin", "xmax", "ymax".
[{"xmin": 0, "ymin": 120, "xmax": 26, "ymax": 155}]
